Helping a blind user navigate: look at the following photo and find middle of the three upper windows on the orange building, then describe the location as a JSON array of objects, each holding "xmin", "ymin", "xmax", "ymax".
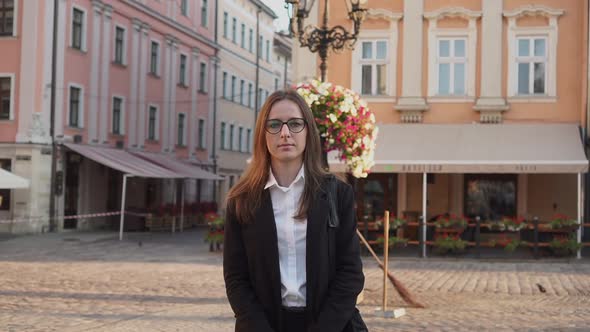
[{"xmin": 436, "ymin": 38, "xmax": 467, "ymax": 96}]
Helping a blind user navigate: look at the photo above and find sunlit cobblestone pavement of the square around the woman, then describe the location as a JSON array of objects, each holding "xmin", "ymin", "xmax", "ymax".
[{"xmin": 0, "ymin": 231, "xmax": 590, "ymax": 332}]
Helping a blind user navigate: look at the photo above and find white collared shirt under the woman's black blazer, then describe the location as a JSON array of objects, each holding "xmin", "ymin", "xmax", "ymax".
[{"xmin": 264, "ymin": 165, "xmax": 307, "ymax": 307}]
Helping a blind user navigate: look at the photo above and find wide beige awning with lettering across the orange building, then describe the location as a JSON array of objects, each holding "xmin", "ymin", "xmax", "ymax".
[{"xmin": 329, "ymin": 124, "xmax": 588, "ymax": 173}]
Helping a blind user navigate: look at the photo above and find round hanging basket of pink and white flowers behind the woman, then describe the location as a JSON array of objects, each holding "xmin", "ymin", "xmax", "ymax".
[{"xmin": 295, "ymin": 80, "xmax": 378, "ymax": 178}]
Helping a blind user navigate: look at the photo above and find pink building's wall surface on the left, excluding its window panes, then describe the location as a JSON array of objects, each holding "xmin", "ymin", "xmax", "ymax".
[{"xmin": 0, "ymin": 0, "xmax": 217, "ymax": 232}]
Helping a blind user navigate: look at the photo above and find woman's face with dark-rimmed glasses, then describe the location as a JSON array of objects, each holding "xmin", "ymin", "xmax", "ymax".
[{"xmin": 265, "ymin": 99, "xmax": 307, "ymax": 163}]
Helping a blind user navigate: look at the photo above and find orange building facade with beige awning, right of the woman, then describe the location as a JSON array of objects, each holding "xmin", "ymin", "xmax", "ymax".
[{"xmin": 293, "ymin": 0, "xmax": 589, "ymax": 256}]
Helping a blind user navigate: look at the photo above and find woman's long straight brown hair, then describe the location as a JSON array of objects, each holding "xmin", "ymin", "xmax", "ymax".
[{"xmin": 227, "ymin": 90, "xmax": 327, "ymax": 224}]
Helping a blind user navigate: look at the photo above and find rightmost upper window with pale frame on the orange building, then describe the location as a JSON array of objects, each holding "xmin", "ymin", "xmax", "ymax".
[{"xmin": 516, "ymin": 37, "xmax": 547, "ymax": 95}]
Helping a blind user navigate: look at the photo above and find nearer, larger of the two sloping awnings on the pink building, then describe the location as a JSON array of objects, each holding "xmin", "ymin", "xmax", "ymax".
[{"xmin": 64, "ymin": 143, "xmax": 183, "ymax": 179}]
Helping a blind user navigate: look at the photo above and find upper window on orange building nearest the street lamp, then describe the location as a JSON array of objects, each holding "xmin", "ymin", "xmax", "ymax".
[{"xmin": 360, "ymin": 40, "xmax": 388, "ymax": 95}]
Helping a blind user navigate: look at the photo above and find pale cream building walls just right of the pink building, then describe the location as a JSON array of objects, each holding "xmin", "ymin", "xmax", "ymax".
[{"xmin": 216, "ymin": 0, "xmax": 280, "ymax": 207}]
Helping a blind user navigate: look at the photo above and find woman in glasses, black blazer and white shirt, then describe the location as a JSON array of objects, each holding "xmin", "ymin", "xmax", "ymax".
[{"xmin": 223, "ymin": 90, "xmax": 364, "ymax": 332}]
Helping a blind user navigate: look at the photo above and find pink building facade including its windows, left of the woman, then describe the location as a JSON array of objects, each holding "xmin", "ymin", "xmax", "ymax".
[{"xmin": 0, "ymin": 0, "xmax": 217, "ymax": 232}]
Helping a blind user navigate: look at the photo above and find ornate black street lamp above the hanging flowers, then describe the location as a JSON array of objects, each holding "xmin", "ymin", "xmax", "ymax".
[{"xmin": 285, "ymin": 0, "xmax": 368, "ymax": 81}]
